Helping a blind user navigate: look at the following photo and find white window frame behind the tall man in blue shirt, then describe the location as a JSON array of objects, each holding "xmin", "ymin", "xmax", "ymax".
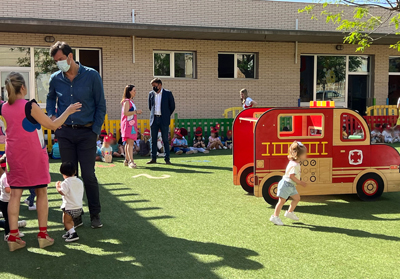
[{"xmin": 0, "ymin": 45, "xmax": 102, "ymax": 108}]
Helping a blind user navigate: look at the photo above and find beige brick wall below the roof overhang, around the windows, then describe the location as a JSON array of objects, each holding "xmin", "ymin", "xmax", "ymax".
[{"xmin": 0, "ymin": 33, "xmax": 398, "ymax": 119}]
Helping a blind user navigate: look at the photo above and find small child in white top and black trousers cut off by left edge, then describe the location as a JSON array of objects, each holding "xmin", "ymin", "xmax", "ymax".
[{"xmin": 0, "ymin": 165, "xmax": 26, "ymax": 241}]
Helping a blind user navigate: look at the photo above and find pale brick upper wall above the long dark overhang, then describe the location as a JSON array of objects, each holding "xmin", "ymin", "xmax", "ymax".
[{"xmin": 0, "ymin": 0, "xmax": 388, "ymax": 31}]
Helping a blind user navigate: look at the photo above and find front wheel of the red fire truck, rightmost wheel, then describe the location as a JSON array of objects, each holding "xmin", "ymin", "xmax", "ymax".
[{"xmin": 357, "ymin": 173, "xmax": 384, "ymax": 201}]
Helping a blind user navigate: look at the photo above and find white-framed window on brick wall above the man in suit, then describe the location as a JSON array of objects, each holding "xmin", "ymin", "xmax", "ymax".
[{"xmin": 153, "ymin": 51, "xmax": 195, "ymax": 78}]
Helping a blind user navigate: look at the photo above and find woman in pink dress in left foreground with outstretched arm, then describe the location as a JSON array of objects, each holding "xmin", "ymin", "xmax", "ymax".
[{"xmin": 0, "ymin": 72, "xmax": 82, "ymax": 251}]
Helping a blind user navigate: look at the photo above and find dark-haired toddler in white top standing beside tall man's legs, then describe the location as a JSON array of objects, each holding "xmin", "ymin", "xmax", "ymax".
[{"xmin": 56, "ymin": 162, "xmax": 83, "ymax": 242}]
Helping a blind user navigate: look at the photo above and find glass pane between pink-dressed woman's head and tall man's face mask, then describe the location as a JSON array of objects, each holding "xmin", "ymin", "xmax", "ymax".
[{"xmin": 34, "ymin": 48, "xmax": 58, "ymax": 103}]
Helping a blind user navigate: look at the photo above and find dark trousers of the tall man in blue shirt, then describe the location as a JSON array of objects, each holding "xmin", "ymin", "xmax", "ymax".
[{"xmin": 56, "ymin": 126, "xmax": 101, "ymax": 215}]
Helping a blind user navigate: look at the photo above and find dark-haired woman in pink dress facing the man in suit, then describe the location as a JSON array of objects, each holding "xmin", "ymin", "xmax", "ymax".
[{"xmin": 121, "ymin": 84, "xmax": 142, "ymax": 168}]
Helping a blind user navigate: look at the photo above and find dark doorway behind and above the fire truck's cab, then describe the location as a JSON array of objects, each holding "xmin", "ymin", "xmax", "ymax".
[{"xmin": 347, "ymin": 75, "xmax": 368, "ymax": 115}]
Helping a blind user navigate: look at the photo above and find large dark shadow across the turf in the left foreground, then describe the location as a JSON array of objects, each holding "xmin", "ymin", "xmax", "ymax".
[{"xmin": 0, "ymin": 167, "xmax": 263, "ymax": 278}]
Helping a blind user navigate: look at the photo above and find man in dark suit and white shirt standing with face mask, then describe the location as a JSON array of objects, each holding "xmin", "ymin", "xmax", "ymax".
[{"xmin": 147, "ymin": 78, "xmax": 175, "ymax": 165}]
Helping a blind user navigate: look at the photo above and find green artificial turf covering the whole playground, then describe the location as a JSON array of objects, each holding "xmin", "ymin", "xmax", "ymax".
[{"xmin": 0, "ymin": 151, "xmax": 400, "ymax": 279}]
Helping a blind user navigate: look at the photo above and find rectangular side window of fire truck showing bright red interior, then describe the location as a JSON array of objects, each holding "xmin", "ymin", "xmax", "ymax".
[{"xmin": 278, "ymin": 114, "xmax": 324, "ymax": 139}]
